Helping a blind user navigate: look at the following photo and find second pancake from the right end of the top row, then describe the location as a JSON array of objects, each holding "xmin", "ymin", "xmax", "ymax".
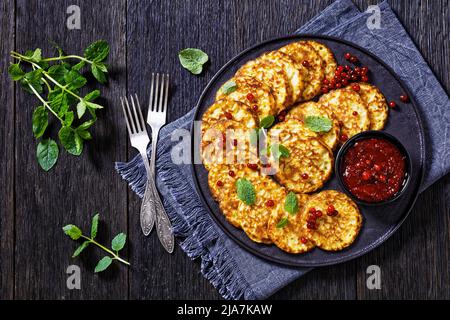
[{"xmin": 278, "ymin": 41, "xmax": 325, "ymax": 100}]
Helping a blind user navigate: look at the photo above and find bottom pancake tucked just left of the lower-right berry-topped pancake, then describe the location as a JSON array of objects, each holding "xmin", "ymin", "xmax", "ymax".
[{"xmin": 267, "ymin": 194, "xmax": 315, "ymax": 253}]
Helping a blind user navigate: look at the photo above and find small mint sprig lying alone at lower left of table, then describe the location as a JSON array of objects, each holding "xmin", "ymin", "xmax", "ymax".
[{"xmin": 63, "ymin": 213, "xmax": 130, "ymax": 273}]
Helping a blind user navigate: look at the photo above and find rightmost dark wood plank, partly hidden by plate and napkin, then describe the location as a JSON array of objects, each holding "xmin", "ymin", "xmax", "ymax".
[{"xmin": 356, "ymin": 0, "xmax": 450, "ymax": 299}]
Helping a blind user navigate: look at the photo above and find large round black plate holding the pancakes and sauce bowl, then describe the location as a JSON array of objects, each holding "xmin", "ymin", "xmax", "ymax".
[{"xmin": 192, "ymin": 35, "xmax": 425, "ymax": 267}]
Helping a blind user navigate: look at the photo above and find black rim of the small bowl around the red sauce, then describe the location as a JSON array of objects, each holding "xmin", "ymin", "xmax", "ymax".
[{"xmin": 334, "ymin": 131, "xmax": 412, "ymax": 206}]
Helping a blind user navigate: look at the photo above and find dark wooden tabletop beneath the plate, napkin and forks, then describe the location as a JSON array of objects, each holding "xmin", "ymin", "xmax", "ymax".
[{"xmin": 0, "ymin": 0, "xmax": 450, "ymax": 299}]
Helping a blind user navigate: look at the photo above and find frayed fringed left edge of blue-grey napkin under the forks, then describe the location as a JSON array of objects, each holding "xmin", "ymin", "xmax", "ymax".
[{"xmin": 115, "ymin": 152, "xmax": 255, "ymax": 299}]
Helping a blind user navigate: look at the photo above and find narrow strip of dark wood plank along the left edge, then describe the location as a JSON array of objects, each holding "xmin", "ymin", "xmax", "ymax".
[{"xmin": 0, "ymin": 1, "xmax": 15, "ymax": 299}]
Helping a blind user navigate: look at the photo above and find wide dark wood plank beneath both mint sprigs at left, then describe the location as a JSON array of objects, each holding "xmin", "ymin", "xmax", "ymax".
[{"xmin": 15, "ymin": 0, "xmax": 128, "ymax": 299}]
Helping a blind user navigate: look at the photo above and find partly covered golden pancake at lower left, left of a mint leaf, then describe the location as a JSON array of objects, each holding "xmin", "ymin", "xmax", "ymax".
[{"xmin": 208, "ymin": 164, "xmax": 259, "ymax": 228}]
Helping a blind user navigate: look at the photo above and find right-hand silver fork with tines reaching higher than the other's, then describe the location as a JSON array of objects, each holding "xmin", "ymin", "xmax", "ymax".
[{"xmin": 147, "ymin": 73, "xmax": 175, "ymax": 252}]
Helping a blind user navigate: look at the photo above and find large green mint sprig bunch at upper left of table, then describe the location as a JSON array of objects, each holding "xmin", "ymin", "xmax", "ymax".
[{"xmin": 8, "ymin": 40, "xmax": 109, "ymax": 171}]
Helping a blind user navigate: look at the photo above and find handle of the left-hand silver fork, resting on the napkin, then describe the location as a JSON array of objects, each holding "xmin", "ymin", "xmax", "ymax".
[{"xmin": 139, "ymin": 152, "xmax": 156, "ymax": 236}]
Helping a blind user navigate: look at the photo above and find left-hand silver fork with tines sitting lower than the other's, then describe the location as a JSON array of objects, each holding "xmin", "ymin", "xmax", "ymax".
[{"xmin": 120, "ymin": 95, "xmax": 156, "ymax": 236}]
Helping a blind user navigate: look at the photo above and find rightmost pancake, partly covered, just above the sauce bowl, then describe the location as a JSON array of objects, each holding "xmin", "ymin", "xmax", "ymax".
[{"xmin": 358, "ymin": 82, "xmax": 389, "ymax": 130}]
